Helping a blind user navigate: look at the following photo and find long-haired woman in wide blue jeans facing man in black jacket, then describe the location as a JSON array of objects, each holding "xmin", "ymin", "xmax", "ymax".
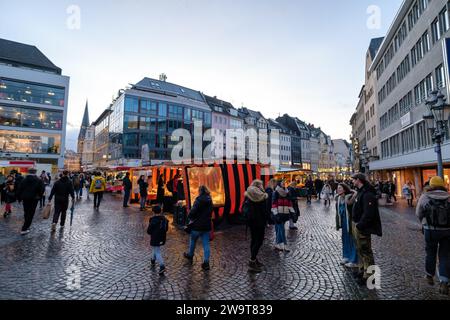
[{"xmin": 336, "ymin": 183, "xmax": 358, "ymax": 268}]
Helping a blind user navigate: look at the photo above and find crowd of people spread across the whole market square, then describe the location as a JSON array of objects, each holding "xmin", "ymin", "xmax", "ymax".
[{"xmin": 0, "ymin": 169, "xmax": 450, "ymax": 294}]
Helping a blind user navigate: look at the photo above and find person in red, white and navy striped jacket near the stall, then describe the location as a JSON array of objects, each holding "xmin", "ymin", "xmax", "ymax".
[{"xmin": 272, "ymin": 181, "xmax": 295, "ymax": 252}]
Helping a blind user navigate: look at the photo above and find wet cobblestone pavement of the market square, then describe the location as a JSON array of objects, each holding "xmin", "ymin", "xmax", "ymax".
[{"xmin": 0, "ymin": 195, "xmax": 448, "ymax": 300}]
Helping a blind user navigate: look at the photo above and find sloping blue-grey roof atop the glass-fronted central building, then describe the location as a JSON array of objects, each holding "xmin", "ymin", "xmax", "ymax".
[{"xmin": 133, "ymin": 78, "xmax": 205, "ymax": 102}]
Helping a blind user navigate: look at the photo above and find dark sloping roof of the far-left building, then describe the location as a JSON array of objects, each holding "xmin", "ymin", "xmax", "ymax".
[{"xmin": 0, "ymin": 39, "xmax": 61, "ymax": 74}]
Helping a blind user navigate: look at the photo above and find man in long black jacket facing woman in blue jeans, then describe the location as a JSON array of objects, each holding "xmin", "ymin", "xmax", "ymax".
[{"xmin": 352, "ymin": 173, "xmax": 383, "ymax": 285}]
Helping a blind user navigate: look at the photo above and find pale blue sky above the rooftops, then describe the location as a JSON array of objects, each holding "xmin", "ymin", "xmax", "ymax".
[{"xmin": 0, "ymin": 0, "xmax": 402, "ymax": 148}]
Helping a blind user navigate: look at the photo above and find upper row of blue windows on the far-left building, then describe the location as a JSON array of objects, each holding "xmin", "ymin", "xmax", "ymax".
[{"xmin": 0, "ymin": 78, "xmax": 66, "ymax": 107}]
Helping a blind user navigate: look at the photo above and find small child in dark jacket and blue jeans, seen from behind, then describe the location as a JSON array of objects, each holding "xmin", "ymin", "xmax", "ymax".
[{"xmin": 147, "ymin": 206, "xmax": 169, "ymax": 276}]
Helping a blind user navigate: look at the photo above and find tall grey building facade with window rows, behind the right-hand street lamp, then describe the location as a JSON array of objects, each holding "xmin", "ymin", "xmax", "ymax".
[{"xmin": 370, "ymin": 0, "xmax": 450, "ymax": 193}]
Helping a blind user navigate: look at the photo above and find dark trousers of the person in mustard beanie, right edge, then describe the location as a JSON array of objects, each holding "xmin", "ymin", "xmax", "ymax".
[{"xmin": 425, "ymin": 229, "xmax": 450, "ymax": 283}]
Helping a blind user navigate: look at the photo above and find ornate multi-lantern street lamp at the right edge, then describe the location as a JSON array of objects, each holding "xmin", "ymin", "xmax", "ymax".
[{"xmin": 423, "ymin": 91, "xmax": 450, "ymax": 178}]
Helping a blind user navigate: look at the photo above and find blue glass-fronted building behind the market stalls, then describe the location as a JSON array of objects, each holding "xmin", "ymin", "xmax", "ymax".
[{"xmin": 96, "ymin": 78, "xmax": 211, "ymax": 165}]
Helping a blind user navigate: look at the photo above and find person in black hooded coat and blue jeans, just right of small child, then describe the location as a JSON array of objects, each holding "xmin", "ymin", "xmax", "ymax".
[{"xmin": 184, "ymin": 186, "xmax": 213, "ymax": 271}]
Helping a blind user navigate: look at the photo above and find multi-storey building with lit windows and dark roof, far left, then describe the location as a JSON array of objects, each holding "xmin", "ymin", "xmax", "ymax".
[{"xmin": 0, "ymin": 39, "xmax": 69, "ymax": 171}]
